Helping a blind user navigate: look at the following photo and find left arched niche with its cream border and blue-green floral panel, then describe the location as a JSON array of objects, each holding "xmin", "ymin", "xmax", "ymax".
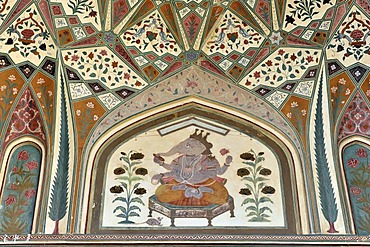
[{"xmin": 0, "ymin": 137, "xmax": 45, "ymax": 234}]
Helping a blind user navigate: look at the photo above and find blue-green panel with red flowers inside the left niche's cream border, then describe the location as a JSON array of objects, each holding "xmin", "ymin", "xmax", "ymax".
[{"xmin": 0, "ymin": 145, "xmax": 41, "ymax": 234}]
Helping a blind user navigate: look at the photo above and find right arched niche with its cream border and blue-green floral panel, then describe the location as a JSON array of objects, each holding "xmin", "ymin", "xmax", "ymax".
[{"xmin": 340, "ymin": 136, "xmax": 370, "ymax": 235}]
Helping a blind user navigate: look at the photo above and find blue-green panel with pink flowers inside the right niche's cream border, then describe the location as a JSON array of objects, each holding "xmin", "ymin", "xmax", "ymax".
[{"xmin": 343, "ymin": 144, "xmax": 370, "ymax": 235}]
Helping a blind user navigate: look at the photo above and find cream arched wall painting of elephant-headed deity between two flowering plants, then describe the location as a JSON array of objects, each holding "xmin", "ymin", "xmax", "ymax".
[{"xmin": 101, "ymin": 119, "xmax": 286, "ymax": 229}]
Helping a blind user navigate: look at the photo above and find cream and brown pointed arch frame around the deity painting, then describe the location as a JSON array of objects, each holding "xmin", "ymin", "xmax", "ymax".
[{"xmin": 81, "ymin": 97, "xmax": 310, "ymax": 234}]
